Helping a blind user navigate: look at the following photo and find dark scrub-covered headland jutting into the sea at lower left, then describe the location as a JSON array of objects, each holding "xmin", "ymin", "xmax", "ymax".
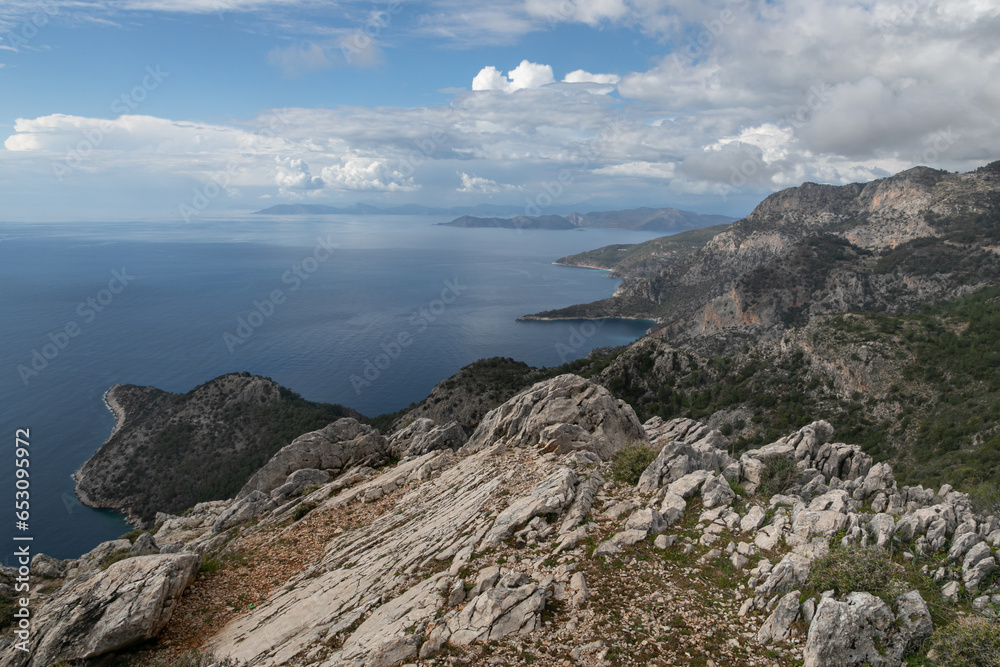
[{"xmin": 76, "ymin": 373, "xmax": 361, "ymax": 522}]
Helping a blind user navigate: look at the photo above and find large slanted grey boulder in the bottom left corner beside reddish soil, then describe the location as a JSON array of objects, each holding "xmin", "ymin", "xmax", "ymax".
[{"xmin": 3, "ymin": 554, "xmax": 201, "ymax": 667}]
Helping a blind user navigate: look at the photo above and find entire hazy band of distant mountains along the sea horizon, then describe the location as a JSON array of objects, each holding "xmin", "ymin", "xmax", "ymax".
[{"xmin": 250, "ymin": 204, "xmax": 736, "ymax": 232}]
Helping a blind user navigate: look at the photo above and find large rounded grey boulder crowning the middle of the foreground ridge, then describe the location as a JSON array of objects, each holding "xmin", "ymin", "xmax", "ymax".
[{"xmin": 462, "ymin": 374, "xmax": 646, "ymax": 460}]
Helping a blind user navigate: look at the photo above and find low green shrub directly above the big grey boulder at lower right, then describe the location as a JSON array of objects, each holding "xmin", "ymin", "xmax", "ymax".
[{"xmin": 806, "ymin": 546, "xmax": 903, "ymax": 604}]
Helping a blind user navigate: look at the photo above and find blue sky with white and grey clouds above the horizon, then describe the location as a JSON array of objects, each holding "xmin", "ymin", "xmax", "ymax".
[{"xmin": 0, "ymin": 0, "xmax": 1000, "ymax": 221}]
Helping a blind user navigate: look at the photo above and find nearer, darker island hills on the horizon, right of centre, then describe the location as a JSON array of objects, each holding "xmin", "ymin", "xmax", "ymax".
[{"xmin": 440, "ymin": 208, "xmax": 736, "ymax": 232}]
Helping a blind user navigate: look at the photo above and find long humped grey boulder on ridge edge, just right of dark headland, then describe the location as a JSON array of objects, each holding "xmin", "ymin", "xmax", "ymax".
[{"xmin": 236, "ymin": 417, "xmax": 389, "ymax": 498}]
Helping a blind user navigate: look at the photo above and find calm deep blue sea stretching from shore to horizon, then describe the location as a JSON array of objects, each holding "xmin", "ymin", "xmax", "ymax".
[{"xmin": 0, "ymin": 216, "xmax": 659, "ymax": 564}]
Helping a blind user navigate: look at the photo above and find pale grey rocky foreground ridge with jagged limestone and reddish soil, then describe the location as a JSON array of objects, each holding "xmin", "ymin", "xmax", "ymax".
[{"xmin": 9, "ymin": 375, "xmax": 1000, "ymax": 667}]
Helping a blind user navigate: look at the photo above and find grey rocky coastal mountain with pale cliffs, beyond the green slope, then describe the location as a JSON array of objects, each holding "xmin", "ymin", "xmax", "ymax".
[{"xmin": 530, "ymin": 163, "xmax": 1000, "ymax": 344}]
